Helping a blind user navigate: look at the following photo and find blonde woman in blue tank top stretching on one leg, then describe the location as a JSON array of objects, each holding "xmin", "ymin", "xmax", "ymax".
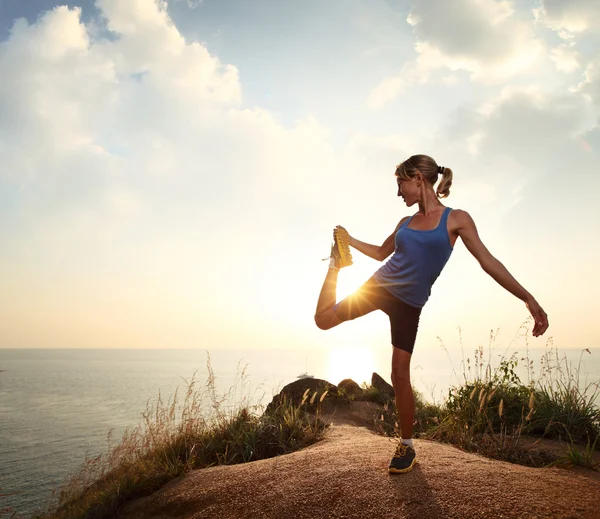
[{"xmin": 315, "ymin": 155, "xmax": 548, "ymax": 473}]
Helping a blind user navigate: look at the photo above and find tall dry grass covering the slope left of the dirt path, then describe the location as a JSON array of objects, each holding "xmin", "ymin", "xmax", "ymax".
[{"xmin": 33, "ymin": 357, "xmax": 326, "ymax": 519}]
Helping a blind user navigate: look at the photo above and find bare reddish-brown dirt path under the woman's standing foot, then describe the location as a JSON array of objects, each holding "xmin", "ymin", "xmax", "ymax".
[{"xmin": 120, "ymin": 425, "xmax": 600, "ymax": 519}]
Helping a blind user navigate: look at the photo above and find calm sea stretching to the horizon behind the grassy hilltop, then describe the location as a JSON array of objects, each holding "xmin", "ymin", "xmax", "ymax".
[{"xmin": 0, "ymin": 347, "xmax": 600, "ymax": 517}]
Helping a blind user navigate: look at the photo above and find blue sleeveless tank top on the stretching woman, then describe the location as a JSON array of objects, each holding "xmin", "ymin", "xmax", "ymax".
[{"xmin": 373, "ymin": 207, "xmax": 452, "ymax": 308}]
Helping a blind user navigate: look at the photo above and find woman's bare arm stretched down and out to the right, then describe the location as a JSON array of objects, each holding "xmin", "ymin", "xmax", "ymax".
[{"xmin": 453, "ymin": 209, "xmax": 548, "ymax": 337}]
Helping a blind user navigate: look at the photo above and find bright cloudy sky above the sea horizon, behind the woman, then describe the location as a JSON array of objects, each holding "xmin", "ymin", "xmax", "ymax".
[{"xmin": 0, "ymin": 0, "xmax": 600, "ymax": 355}]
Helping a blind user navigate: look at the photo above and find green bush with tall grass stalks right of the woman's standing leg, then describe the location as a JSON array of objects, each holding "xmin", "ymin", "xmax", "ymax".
[{"xmin": 426, "ymin": 334, "xmax": 600, "ymax": 472}]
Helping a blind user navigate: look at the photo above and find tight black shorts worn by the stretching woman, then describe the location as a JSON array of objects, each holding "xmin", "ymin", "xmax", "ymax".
[{"xmin": 334, "ymin": 277, "xmax": 421, "ymax": 353}]
